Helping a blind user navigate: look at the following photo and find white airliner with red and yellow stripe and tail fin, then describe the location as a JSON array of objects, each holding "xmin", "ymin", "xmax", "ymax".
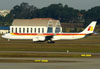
[{"xmin": 2, "ymin": 21, "xmax": 97, "ymax": 43}]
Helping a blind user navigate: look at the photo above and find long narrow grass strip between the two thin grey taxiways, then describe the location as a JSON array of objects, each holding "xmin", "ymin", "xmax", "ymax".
[{"xmin": 0, "ymin": 53, "xmax": 100, "ymax": 58}]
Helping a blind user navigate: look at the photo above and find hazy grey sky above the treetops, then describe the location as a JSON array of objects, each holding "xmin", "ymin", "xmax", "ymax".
[{"xmin": 0, "ymin": 0, "xmax": 100, "ymax": 10}]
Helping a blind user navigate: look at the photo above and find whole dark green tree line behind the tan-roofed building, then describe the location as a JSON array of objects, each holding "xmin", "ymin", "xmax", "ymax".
[{"xmin": 0, "ymin": 2, "xmax": 100, "ymax": 26}]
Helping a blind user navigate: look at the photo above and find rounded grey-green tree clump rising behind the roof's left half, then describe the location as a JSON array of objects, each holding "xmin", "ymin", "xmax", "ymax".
[{"xmin": 6, "ymin": 2, "xmax": 37, "ymax": 21}]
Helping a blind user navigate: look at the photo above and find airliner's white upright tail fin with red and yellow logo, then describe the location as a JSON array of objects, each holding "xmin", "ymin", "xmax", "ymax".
[{"xmin": 81, "ymin": 21, "xmax": 97, "ymax": 34}]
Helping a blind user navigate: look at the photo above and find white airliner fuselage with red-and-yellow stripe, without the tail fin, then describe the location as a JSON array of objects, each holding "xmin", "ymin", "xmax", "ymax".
[{"xmin": 2, "ymin": 33, "xmax": 87, "ymax": 41}]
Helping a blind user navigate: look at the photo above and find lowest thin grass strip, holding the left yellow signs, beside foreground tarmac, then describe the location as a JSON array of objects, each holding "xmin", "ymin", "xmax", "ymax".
[{"xmin": 0, "ymin": 59, "xmax": 79, "ymax": 63}]
